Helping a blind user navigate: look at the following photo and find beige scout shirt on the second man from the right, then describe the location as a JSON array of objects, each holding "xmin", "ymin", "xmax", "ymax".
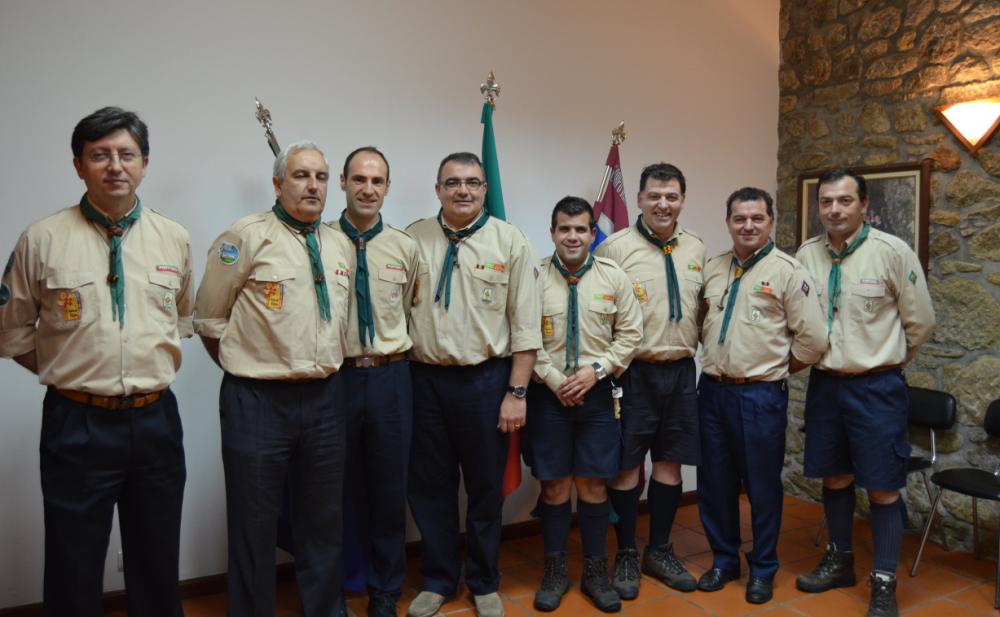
[{"xmin": 701, "ymin": 248, "xmax": 827, "ymax": 381}]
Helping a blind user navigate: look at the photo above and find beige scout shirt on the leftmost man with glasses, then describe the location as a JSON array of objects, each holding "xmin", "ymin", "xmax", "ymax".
[{"xmin": 0, "ymin": 206, "xmax": 194, "ymax": 396}]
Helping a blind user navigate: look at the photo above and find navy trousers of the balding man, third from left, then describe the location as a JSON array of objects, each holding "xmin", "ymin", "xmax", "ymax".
[{"xmin": 337, "ymin": 360, "xmax": 413, "ymax": 596}]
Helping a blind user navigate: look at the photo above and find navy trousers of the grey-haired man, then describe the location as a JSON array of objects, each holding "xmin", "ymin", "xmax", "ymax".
[{"xmin": 219, "ymin": 373, "xmax": 345, "ymax": 617}]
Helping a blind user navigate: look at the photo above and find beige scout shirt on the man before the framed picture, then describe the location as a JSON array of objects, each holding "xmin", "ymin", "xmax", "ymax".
[{"xmin": 796, "ymin": 228, "xmax": 934, "ymax": 373}]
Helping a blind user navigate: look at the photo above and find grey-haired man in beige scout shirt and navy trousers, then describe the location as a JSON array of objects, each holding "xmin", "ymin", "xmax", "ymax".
[{"xmin": 194, "ymin": 142, "xmax": 353, "ymax": 617}]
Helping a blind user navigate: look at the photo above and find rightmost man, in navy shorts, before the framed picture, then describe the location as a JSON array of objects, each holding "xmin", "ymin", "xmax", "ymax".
[{"xmin": 795, "ymin": 169, "xmax": 934, "ymax": 616}]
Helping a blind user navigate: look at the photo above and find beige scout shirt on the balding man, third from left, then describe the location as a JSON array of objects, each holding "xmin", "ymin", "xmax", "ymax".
[{"xmin": 327, "ymin": 220, "xmax": 420, "ymax": 358}]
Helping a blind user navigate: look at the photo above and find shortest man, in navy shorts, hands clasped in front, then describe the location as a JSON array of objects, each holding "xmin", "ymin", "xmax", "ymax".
[{"xmin": 524, "ymin": 197, "xmax": 642, "ymax": 612}]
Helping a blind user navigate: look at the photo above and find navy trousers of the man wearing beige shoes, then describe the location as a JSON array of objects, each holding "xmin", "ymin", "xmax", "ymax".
[{"xmin": 408, "ymin": 358, "xmax": 510, "ymax": 596}]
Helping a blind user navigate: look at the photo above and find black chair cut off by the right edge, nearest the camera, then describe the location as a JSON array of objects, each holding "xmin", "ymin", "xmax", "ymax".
[{"xmin": 910, "ymin": 399, "xmax": 1000, "ymax": 608}]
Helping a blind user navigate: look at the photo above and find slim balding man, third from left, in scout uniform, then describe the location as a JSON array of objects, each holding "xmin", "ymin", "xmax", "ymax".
[{"xmin": 329, "ymin": 146, "xmax": 418, "ymax": 617}]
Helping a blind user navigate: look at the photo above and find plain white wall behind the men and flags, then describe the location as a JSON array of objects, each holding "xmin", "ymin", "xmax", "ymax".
[{"xmin": 0, "ymin": 0, "xmax": 778, "ymax": 607}]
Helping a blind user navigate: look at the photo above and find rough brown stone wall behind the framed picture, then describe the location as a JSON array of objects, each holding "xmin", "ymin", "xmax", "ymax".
[{"xmin": 777, "ymin": 0, "xmax": 1000, "ymax": 548}]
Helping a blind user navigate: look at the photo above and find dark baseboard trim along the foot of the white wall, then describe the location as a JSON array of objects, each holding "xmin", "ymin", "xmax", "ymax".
[{"xmin": 0, "ymin": 491, "xmax": 698, "ymax": 617}]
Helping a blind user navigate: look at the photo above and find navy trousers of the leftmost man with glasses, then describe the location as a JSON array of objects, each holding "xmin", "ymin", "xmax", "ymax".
[{"xmin": 39, "ymin": 388, "xmax": 187, "ymax": 617}]
